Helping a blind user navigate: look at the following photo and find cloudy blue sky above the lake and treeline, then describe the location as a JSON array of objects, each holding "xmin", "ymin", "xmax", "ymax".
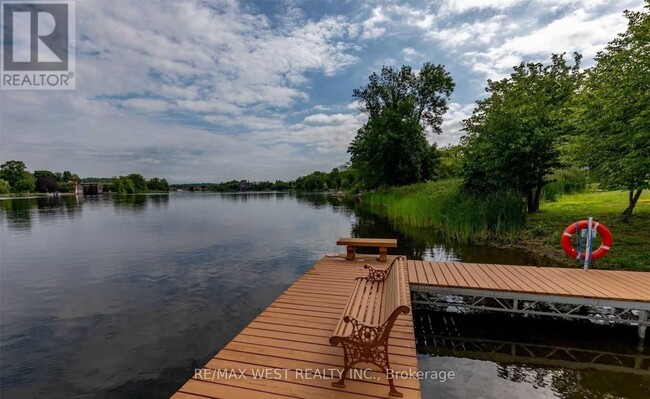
[{"xmin": 0, "ymin": 0, "xmax": 643, "ymax": 183}]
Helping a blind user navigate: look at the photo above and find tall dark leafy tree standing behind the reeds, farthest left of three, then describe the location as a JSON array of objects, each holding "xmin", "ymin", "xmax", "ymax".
[{"xmin": 348, "ymin": 63, "xmax": 454, "ymax": 187}]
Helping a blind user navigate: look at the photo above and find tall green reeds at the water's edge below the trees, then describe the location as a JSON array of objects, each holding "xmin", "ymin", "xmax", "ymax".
[{"xmin": 364, "ymin": 179, "xmax": 525, "ymax": 242}]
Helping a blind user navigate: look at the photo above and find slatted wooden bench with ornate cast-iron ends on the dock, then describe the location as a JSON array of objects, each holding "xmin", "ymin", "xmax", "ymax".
[{"xmin": 330, "ymin": 257, "xmax": 411, "ymax": 396}]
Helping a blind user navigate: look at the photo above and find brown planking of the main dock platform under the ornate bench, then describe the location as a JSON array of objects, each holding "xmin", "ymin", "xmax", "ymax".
[{"xmin": 172, "ymin": 255, "xmax": 421, "ymax": 399}]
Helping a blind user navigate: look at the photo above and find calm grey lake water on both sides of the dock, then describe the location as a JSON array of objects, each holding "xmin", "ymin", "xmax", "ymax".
[{"xmin": 0, "ymin": 193, "xmax": 650, "ymax": 398}]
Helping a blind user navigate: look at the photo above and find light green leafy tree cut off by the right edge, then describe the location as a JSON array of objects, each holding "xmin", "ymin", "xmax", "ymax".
[{"xmin": 571, "ymin": 1, "xmax": 650, "ymax": 220}]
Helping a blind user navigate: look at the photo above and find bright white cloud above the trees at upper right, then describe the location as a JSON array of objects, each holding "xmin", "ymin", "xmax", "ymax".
[{"xmin": 425, "ymin": 0, "xmax": 642, "ymax": 79}]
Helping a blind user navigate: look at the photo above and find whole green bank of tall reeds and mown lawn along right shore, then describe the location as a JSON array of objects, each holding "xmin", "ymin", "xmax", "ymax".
[{"xmin": 363, "ymin": 179, "xmax": 650, "ymax": 271}]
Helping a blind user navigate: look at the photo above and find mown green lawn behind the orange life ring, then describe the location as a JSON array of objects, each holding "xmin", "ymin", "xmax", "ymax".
[{"xmin": 521, "ymin": 190, "xmax": 650, "ymax": 271}]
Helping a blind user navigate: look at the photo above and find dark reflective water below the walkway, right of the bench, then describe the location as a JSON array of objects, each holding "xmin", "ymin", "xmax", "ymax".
[{"xmin": 414, "ymin": 308, "xmax": 650, "ymax": 398}]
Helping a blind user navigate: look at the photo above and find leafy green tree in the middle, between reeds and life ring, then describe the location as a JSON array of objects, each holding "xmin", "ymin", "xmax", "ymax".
[{"xmin": 463, "ymin": 54, "xmax": 581, "ymax": 216}]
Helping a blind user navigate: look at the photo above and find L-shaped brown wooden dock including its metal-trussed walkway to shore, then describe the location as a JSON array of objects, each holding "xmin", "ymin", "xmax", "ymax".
[{"xmin": 172, "ymin": 254, "xmax": 650, "ymax": 399}]
